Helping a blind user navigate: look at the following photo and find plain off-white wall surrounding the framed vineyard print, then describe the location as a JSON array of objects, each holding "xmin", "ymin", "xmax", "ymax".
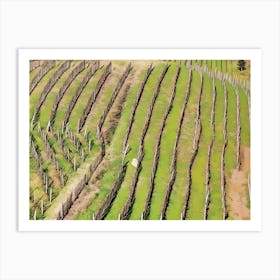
[{"xmin": 0, "ymin": 0, "xmax": 280, "ymax": 280}]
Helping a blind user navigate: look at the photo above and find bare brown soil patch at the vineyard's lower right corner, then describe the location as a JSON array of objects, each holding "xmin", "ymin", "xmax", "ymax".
[{"xmin": 226, "ymin": 146, "xmax": 250, "ymax": 220}]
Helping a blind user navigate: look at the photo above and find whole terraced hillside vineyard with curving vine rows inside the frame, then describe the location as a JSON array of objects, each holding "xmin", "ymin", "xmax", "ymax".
[{"xmin": 29, "ymin": 60, "xmax": 250, "ymax": 220}]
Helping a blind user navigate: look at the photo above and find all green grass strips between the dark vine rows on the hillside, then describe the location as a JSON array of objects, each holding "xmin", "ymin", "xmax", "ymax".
[{"xmin": 29, "ymin": 60, "xmax": 250, "ymax": 220}]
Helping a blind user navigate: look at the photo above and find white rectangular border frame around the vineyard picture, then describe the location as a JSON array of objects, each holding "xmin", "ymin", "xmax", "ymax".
[{"xmin": 18, "ymin": 49, "xmax": 262, "ymax": 231}]
